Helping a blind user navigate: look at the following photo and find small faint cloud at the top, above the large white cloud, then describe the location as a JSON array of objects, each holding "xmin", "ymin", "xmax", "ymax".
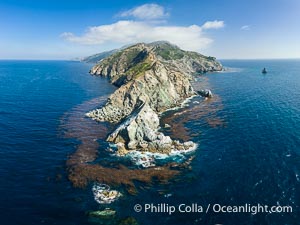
[{"xmin": 120, "ymin": 4, "xmax": 168, "ymax": 20}]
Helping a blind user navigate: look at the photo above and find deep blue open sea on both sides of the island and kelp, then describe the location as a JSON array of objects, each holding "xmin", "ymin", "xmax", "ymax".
[{"xmin": 0, "ymin": 60, "xmax": 300, "ymax": 225}]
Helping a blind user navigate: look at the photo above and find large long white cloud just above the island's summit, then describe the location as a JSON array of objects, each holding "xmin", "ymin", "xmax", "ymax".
[{"xmin": 61, "ymin": 20, "xmax": 213, "ymax": 51}]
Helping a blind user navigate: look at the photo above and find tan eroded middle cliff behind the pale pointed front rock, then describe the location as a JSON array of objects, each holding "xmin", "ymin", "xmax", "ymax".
[{"xmin": 87, "ymin": 62, "xmax": 195, "ymax": 122}]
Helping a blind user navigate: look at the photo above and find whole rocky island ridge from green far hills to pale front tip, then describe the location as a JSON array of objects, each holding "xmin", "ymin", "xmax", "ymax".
[{"xmin": 86, "ymin": 42, "xmax": 223, "ymax": 155}]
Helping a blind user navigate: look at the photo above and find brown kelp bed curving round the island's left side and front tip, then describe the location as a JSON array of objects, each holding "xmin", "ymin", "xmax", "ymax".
[{"xmin": 61, "ymin": 96, "xmax": 182, "ymax": 193}]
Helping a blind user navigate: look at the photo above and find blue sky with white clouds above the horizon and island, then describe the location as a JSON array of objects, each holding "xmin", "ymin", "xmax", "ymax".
[{"xmin": 0, "ymin": 0, "xmax": 300, "ymax": 60}]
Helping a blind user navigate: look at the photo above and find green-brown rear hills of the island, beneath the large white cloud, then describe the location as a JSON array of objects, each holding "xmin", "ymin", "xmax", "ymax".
[{"xmin": 93, "ymin": 41, "xmax": 222, "ymax": 83}]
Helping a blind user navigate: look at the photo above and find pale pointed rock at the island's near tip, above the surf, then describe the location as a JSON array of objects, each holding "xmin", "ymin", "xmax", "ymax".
[{"xmin": 107, "ymin": 102, "xmax": 194, "ymax": 155}]
